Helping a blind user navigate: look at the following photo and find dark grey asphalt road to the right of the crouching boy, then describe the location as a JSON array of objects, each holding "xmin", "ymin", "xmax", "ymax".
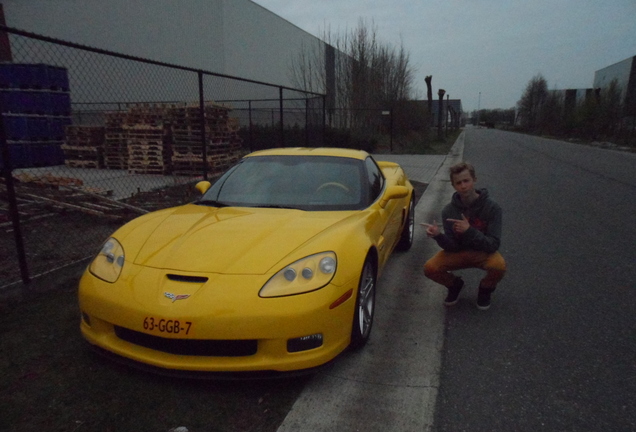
[{"xmin": 433, "ymin": 128, "xmax": 636, "ymax": 432}]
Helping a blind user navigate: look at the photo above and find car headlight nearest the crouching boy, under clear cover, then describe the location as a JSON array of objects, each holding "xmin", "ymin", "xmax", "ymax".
[{"xmin": 258, "ymin": 252, "xmax": 337, "ymax": 297}]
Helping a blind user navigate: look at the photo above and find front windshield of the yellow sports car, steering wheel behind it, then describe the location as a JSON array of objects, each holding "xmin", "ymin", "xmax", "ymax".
[{"xmin": 199, "ymin": 156, "xmax": 368, "ymax": 211}]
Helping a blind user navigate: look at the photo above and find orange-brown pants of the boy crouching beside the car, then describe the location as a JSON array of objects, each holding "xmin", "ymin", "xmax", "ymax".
[{"xmin": 424, "ymin": 250, "xmax": 506, "ymax": 289}]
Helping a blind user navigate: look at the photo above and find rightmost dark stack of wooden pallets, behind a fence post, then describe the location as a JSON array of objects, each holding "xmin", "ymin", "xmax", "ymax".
[{"xmin": 171, "ymin": 103, "xmax": 241, "ymax": 175}]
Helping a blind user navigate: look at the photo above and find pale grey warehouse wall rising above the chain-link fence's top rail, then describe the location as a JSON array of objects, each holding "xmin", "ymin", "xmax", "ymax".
[{"xmin": 1, "ymin": 0, "xmax": 323, "ymax": 87}]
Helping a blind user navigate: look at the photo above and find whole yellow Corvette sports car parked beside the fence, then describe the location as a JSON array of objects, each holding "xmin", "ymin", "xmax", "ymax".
[{"xmin": 79, "ymin": 148, "xmax": 414, "ymax": 375}]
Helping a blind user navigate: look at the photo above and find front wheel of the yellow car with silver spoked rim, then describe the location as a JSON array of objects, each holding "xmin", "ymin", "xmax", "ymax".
[{"xmin": 351, "ymin": 257, "xmax": 377, "ymax": 349}]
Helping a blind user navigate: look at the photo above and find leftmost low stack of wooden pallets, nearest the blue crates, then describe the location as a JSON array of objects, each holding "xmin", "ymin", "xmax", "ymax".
[{"xmin": 62, "ymin": 126, "xmax": 104, "ymax": 168}]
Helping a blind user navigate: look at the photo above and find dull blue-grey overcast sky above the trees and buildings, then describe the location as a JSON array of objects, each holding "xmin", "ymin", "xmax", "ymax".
[{"xmin": 254, "ymin": 0, "xmax": 636, "ymax": 111}]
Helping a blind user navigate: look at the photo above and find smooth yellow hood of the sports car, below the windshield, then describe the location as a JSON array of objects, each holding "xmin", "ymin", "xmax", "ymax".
[{"xmin": 125, "ymin": 205, "xmax": 352, "ymax": 274}]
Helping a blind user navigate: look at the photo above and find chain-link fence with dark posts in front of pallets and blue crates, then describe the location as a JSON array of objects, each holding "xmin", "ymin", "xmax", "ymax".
[{"xmin": 0, "ymin": 26, "xmax": 325, "ymax": 288}]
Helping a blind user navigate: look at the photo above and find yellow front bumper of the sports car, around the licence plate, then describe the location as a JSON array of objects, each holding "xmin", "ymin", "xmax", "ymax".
[{"xmin": 79, "ymin": 268, "xmax": 357, "ymax": 373}]
